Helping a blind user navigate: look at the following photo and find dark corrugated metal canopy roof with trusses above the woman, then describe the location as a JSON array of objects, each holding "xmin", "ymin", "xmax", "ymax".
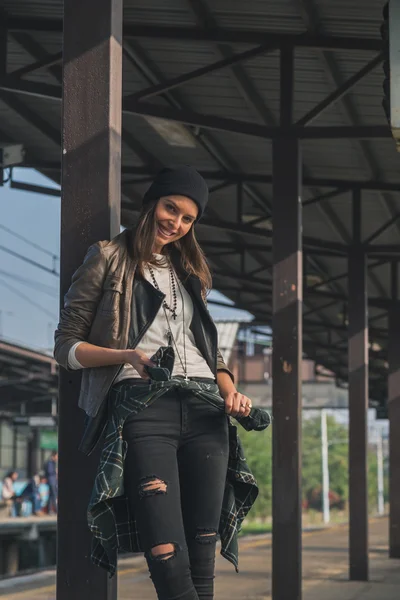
[{"xmin": 0, "ymin": 0, "xmax": 400, "ymax": 403}]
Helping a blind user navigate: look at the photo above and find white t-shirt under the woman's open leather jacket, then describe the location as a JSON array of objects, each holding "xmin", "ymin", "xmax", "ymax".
[{"xmin": 68, "ymin": 254, "xmax": 214, "ymax": 383}]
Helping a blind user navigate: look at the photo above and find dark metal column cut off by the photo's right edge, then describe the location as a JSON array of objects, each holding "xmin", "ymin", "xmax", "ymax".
[{"xmin": 388, "ymin": 262, "xmax": 400, "ymax": 558}]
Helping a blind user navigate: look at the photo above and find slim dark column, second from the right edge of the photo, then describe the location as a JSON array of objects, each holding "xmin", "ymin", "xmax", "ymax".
[{"xmin": 348, "ymin": 191, "xmax": 368, "ymax": 581}]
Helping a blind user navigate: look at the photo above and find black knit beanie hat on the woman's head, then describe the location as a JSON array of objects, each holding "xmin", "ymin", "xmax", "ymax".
[{"xmin": 143, "ymin": 165, "xmax": 208, "ymax": 221}]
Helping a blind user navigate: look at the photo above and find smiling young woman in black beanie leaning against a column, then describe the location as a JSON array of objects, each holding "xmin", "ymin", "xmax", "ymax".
[{"xmin": 55, "ymin": 166, "xmax": 269, "ymax": 600}]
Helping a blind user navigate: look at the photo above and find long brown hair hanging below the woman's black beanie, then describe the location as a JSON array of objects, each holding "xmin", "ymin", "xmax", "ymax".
[{"xmin": 133, "ymin": 201, "xmax": 212, "ymax": 299}]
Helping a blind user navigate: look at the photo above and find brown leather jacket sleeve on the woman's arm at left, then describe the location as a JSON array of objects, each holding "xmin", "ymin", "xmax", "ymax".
[{"xmin": 54, "ymin": 242, "xmax": 107, "ymax": 370}]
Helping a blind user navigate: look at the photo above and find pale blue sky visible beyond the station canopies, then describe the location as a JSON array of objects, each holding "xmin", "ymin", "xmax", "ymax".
[{"xmin": 0, "ymin": 168, "xmax": 251, "ymax": 353}]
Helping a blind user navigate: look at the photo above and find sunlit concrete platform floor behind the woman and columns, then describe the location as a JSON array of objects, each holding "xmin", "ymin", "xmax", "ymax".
[{"xmin": 0, "ymin": 518, "xmax": 400, "ymax": 600}]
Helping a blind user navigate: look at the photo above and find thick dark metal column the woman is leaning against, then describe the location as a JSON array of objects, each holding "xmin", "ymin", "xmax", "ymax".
[{"xmin": 57, "ymin": 0, "xmax": 123, "ymax": 600}]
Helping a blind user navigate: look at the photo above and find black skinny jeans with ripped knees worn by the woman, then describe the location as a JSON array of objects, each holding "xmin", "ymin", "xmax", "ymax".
[{"xmin": 123, "ymin": 380, "xmax": 229, "ymax": 600}]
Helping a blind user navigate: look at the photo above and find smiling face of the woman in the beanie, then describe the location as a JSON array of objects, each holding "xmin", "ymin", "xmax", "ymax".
[{"xmin": 153, "ymin": 196, "xmax": 199, "ymax": 254}]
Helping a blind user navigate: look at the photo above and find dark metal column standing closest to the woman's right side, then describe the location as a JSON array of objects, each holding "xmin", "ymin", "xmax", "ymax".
[{"xmin": 272, "ymin": 49, "xmax": 303, "ymax": 600}]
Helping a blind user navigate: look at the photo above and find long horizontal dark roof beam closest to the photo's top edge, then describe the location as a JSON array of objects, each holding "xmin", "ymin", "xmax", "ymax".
[{"xmin": 8, "ymin": 16, "xmax": 381, "ymax": 52}]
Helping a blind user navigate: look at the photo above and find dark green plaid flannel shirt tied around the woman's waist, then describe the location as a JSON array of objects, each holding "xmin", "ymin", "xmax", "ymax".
[{"xmin": 88, "ymin": 378, "xmax": 271, "ymax": 576}]
